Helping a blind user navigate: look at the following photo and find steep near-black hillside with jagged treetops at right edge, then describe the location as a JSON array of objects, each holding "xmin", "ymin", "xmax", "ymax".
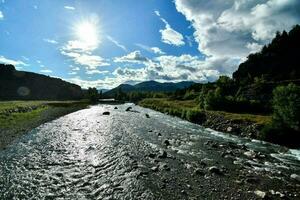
[{"xmin": 233, "ymin": 25, "xmax": 300, "ymax": 85}]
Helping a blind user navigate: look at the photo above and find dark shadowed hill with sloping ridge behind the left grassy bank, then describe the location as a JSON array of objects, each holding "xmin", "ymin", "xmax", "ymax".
[{"xmin": 0, "ymin": 64, "xmax": 83, "ymax": 100}]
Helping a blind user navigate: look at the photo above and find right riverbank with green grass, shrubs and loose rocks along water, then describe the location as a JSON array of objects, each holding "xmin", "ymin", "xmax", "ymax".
[{"xmin": 138, "ymin": 98, "xmax": 271, "ymax": 139}]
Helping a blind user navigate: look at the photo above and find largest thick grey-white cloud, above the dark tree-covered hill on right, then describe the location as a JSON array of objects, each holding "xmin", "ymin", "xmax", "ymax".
[{"xmin": 175, "ymin": 0, "xmax": 300, "ymax": 58}]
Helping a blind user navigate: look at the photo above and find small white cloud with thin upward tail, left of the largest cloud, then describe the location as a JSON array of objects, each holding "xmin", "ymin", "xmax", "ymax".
[{"xmin": 154, "ymin": 11, "xmax": 185, "ymax": 46}]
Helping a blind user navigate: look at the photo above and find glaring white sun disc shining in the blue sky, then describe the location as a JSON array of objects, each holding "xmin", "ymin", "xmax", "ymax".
[{"xmin": 75, "ymin": 21, "xmax": 99, "ymax": 46}]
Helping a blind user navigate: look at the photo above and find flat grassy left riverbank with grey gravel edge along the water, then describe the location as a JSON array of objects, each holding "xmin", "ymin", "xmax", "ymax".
[{"xmin": 0, "ymin": 101, "xmax": 89, "ymax": 149}]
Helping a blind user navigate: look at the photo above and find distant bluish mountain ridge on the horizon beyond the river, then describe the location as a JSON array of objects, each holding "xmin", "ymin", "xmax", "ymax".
[{"xmin": 104, "ymin": 81, "xmax": 195, "ymax": 97}]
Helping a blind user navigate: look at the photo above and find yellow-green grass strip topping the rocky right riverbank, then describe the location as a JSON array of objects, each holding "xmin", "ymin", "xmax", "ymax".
[{"xmin": 139, "ymin": 98, "xmax": 271, "ymax": 125}]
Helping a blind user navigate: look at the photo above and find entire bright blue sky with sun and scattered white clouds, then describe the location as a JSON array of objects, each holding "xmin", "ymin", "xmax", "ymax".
[{"xmin": 0, "ymin": 0, "xmax": 300, "ymax": 88}]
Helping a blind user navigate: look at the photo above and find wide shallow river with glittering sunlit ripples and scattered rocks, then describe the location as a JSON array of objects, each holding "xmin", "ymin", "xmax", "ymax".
[{"xmin": 0, "ymin": 104, "xmax": 300, "ymax": 199}]
